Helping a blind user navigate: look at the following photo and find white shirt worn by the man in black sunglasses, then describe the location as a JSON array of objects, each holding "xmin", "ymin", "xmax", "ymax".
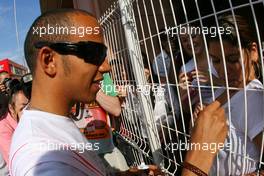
[{"xmin": 9, "ymin": 110, "xmax": 106, "ymax": 176}]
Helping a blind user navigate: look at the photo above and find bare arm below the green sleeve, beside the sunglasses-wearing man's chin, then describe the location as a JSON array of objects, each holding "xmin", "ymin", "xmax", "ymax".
[{"xmin": 96, "ymin": 90, "xmax": 121, "ymax": 117}]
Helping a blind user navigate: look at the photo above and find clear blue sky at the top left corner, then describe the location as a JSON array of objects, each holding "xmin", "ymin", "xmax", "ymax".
[{"xmin": 0, "ymin": 0, "xmax": 40, "ymax": 65}]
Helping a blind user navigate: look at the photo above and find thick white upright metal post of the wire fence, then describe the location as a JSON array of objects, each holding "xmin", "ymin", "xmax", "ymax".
[{"xmin": 118, "ymin": 0, "xmax": 163, "ymax": 166}]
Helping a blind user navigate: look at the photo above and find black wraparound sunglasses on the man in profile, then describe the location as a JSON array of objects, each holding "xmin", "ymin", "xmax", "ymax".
[{"xmin": 34, "ymin": 41, "xmax": 107, "ymax": 66}]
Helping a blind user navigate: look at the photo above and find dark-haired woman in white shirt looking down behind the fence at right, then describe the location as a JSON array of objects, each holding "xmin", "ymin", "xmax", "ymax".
[{"xmin": 206, "ymin": 14, "xmax": 264, "ymax": 176}]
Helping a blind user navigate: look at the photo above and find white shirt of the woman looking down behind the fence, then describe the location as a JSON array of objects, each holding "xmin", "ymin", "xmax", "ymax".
[{"xmin": 210, "ymin": 80, "xmax": 264, "ymax": 176}]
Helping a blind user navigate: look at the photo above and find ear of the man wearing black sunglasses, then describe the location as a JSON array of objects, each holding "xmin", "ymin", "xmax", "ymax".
[{"xmin": 38, "ymin": 47, "xmax": 58, "ymax": 77}]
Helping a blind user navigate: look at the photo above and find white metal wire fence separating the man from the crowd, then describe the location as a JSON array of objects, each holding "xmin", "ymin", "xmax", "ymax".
[{"xmin": 99, "ymin": 0, "xmax": 264, "ymax": 176}]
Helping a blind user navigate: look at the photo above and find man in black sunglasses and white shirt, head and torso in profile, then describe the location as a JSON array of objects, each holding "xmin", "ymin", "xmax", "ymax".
[{"xmin": 9, "ymin": 9, "xmax": 109, "ymax": 176}]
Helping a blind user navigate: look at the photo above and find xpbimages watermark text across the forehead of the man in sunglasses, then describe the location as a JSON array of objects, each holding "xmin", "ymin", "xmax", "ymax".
[{"xmin": 32, "ymin": 24, "xmax": 100, "ymax": 37}]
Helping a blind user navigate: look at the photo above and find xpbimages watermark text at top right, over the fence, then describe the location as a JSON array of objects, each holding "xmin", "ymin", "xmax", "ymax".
[{"xmin": 165, "ymin": 24, "xmax": 232, "ymax": 37}]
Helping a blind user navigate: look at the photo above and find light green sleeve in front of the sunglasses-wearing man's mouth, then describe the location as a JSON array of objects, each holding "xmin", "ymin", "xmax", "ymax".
[{"xmin": 102, "ymin": 73, "xmax": 118, "ymax": 97}]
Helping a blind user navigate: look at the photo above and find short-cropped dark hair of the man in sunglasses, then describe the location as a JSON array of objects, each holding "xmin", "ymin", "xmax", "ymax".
[{"xmin": 24, "ymin": 9, "xmax": 93, "ymax": 75}]
